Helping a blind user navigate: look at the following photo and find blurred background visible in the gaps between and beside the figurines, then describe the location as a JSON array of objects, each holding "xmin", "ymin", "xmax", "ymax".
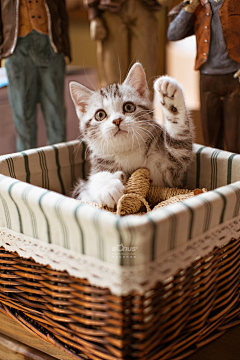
[{"xmin": 0, "ymin": 0, "xmax": 203, "ymax": 155}]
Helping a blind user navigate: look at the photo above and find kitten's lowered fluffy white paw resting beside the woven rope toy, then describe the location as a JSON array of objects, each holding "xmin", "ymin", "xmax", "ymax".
[{"xmin": 89, "ymin": 171, "xmax": 127, "ymax": 208}]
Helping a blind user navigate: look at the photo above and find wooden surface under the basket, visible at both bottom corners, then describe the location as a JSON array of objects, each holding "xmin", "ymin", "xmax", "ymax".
[{"xmin": 0, "ymin": 313, "xmax": 240, "ymax": 360}]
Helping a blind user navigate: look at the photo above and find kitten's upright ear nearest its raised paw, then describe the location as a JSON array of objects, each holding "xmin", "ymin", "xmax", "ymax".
[{"xmin": 124, "ymin": 63, "xmax": 149, "ymax": 96}]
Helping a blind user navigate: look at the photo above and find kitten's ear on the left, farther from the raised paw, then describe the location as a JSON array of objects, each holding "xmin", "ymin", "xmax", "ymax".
[{"xmin": 69, "ymin": 81, "xmax": 93, "ymax": 113}]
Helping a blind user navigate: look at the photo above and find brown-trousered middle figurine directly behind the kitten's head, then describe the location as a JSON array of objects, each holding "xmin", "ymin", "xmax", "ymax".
[{"xmin": 84, "ymin": 0, "xmax": 171, "ymax": 86}]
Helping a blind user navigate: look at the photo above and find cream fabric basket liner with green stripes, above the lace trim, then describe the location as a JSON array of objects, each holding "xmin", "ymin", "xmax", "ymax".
[{"xmin": 0, "ymin": 141, "xmax": 240, "ymax": 266}]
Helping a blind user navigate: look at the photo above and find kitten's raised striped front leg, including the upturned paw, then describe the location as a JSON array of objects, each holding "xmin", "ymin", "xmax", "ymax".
[{"xmin": 154, "ymin": 76, "xmax": 193, "ymax": 186}]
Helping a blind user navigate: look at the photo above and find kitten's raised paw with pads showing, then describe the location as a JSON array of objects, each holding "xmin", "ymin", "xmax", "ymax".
[{"xmin": 154, "ymin": 76, "xmax": 186, "ymax": 115}]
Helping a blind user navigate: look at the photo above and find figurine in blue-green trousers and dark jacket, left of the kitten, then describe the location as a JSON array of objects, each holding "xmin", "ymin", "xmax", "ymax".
[{"xmin": 0, "ymin": 0, "xmax": 71, "ymax": 151}]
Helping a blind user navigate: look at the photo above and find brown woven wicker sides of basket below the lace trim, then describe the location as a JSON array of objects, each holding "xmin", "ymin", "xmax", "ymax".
[{"xmin": 0, "ymin": 235, "xmax": 240, "ymax": 360}]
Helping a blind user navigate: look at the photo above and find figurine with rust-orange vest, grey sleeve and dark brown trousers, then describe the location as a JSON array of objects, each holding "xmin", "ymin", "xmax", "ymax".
[{"xmin": 168, "ymin": 0, "xmax": 240, "ymax": 153}]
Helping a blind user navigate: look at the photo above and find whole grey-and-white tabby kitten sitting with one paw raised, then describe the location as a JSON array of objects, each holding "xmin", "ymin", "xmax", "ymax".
[{"xmin": 70, "ymin": 63, "xmax": 193, "ymax": 208}]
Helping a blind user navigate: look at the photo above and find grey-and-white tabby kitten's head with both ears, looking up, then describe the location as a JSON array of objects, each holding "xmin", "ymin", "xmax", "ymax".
[{"xmin": 70, "ymin": 63, "xmax": 152, "ymax": 156}]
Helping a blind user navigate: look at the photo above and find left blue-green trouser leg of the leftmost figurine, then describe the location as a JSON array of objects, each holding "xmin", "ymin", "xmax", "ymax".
[{"xmin": 5, "ymin": 34, "xmax": 38, "ymax": 151}]
